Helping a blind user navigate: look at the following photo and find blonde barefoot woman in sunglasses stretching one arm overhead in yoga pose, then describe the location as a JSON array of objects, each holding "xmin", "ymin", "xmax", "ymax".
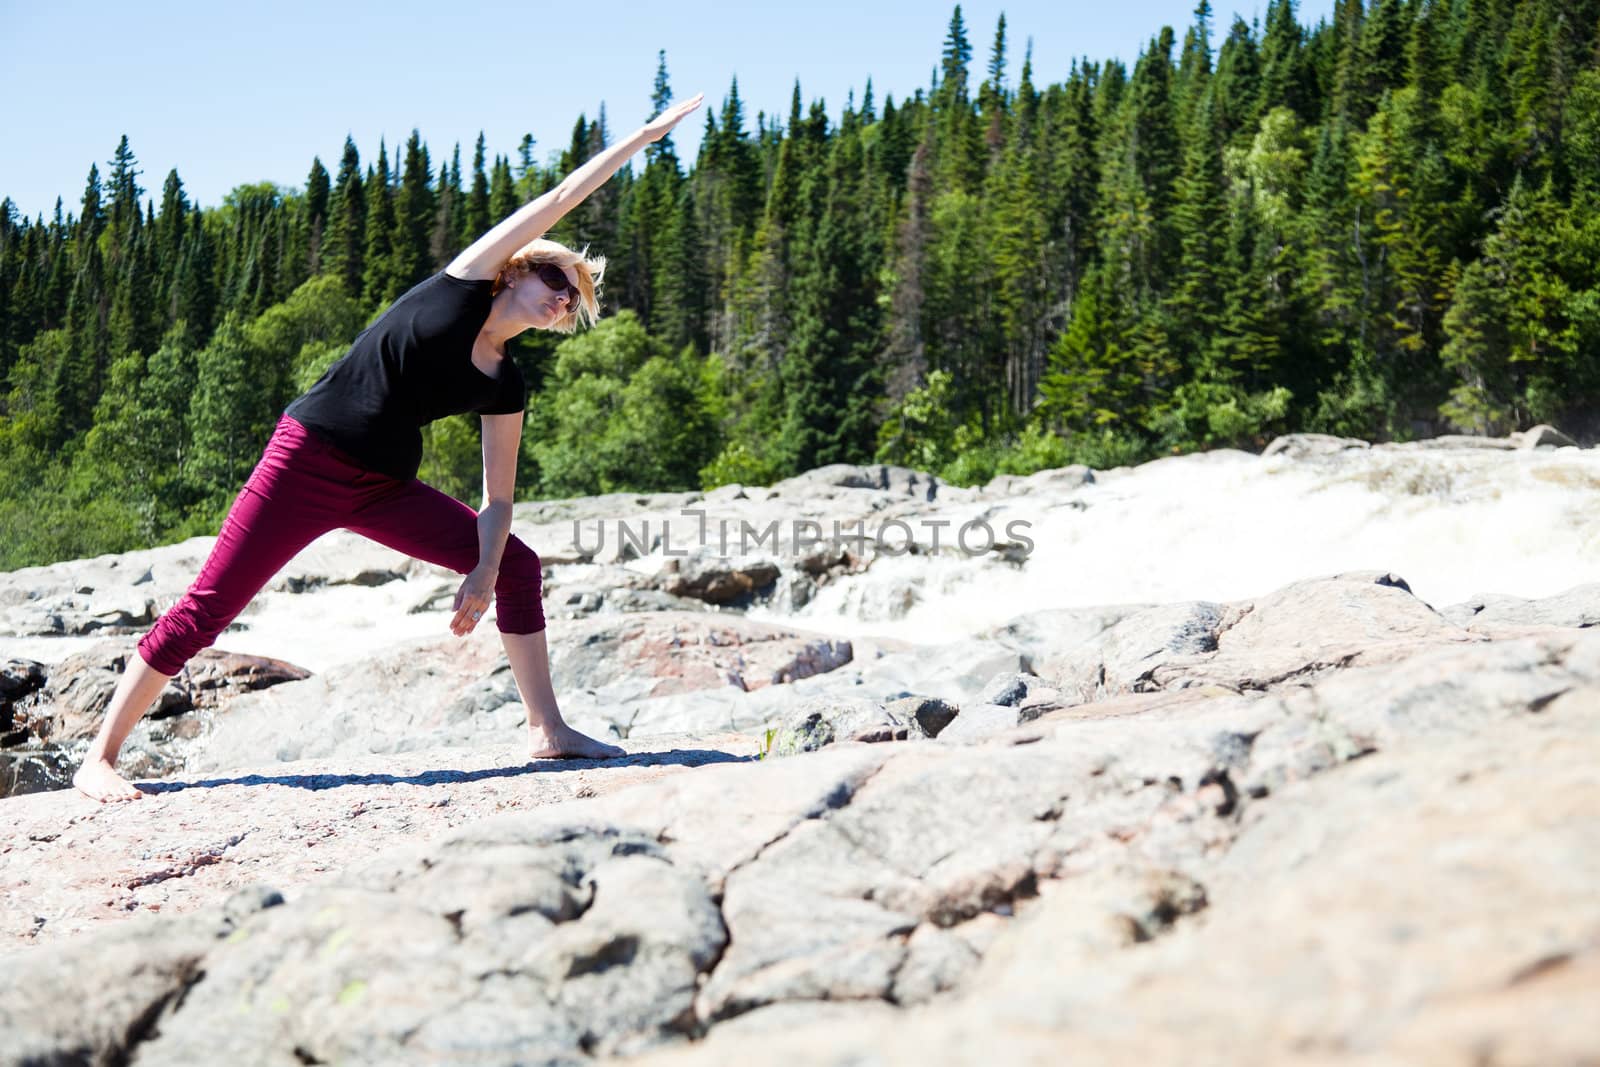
[{"xmin": 72, "ymin": 96, "xmax": 701, "ymax": 801}]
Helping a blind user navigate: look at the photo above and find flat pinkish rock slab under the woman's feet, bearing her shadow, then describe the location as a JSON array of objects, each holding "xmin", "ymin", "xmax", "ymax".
[{"xmin": 0, "ymin": 734, "xmax": 755, "ymax": 955}]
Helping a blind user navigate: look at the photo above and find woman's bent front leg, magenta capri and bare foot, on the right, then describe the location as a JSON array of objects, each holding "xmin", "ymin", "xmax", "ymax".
[{"xmin": 347, "ymin": 482, "xmax": 624, "ymax": 760}]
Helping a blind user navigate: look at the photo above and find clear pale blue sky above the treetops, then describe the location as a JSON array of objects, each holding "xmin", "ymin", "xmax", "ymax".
[{"xmin": 0, "ymin": 0, "xmax": 1333, "ymax": 216}]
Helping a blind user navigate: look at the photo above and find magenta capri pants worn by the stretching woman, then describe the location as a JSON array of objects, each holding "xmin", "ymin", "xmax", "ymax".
[{"xmin": 139, "ymin": 416, "xmax": 544, "ymax": 675}]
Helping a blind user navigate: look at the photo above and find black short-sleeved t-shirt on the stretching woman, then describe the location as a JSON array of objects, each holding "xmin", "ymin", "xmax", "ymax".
[{"xmin": 286, "ymin": 272, "xmax": 528, "ymax": 480}]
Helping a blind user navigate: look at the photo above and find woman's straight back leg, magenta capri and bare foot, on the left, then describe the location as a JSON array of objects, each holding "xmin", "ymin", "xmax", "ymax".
[{"xmin": 72, "ymin": 426, "xmax": 344, "ymax": 800}]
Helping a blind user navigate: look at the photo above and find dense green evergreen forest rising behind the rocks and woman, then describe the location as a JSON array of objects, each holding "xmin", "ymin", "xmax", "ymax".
[{"xmin": 0, "ymin": 0, "xmax": 1600, "ymax": 568}]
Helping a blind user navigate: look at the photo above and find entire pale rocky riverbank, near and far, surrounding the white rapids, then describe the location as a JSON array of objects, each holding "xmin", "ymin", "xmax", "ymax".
[{"xmin": 0, "ymin": 451, "xmax": 1600, "ymax": 1067}]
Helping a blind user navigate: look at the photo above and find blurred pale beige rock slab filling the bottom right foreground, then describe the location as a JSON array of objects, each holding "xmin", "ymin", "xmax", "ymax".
[{"xmin": 635, "ymin": 686, "xmax": 1600, "ymax": 1067}]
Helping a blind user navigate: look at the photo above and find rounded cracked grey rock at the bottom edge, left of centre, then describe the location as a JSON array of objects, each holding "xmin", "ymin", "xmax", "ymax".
[{"xmin": 114, "ymin": 824, "xmax": 726, "ymax": 1064}]
